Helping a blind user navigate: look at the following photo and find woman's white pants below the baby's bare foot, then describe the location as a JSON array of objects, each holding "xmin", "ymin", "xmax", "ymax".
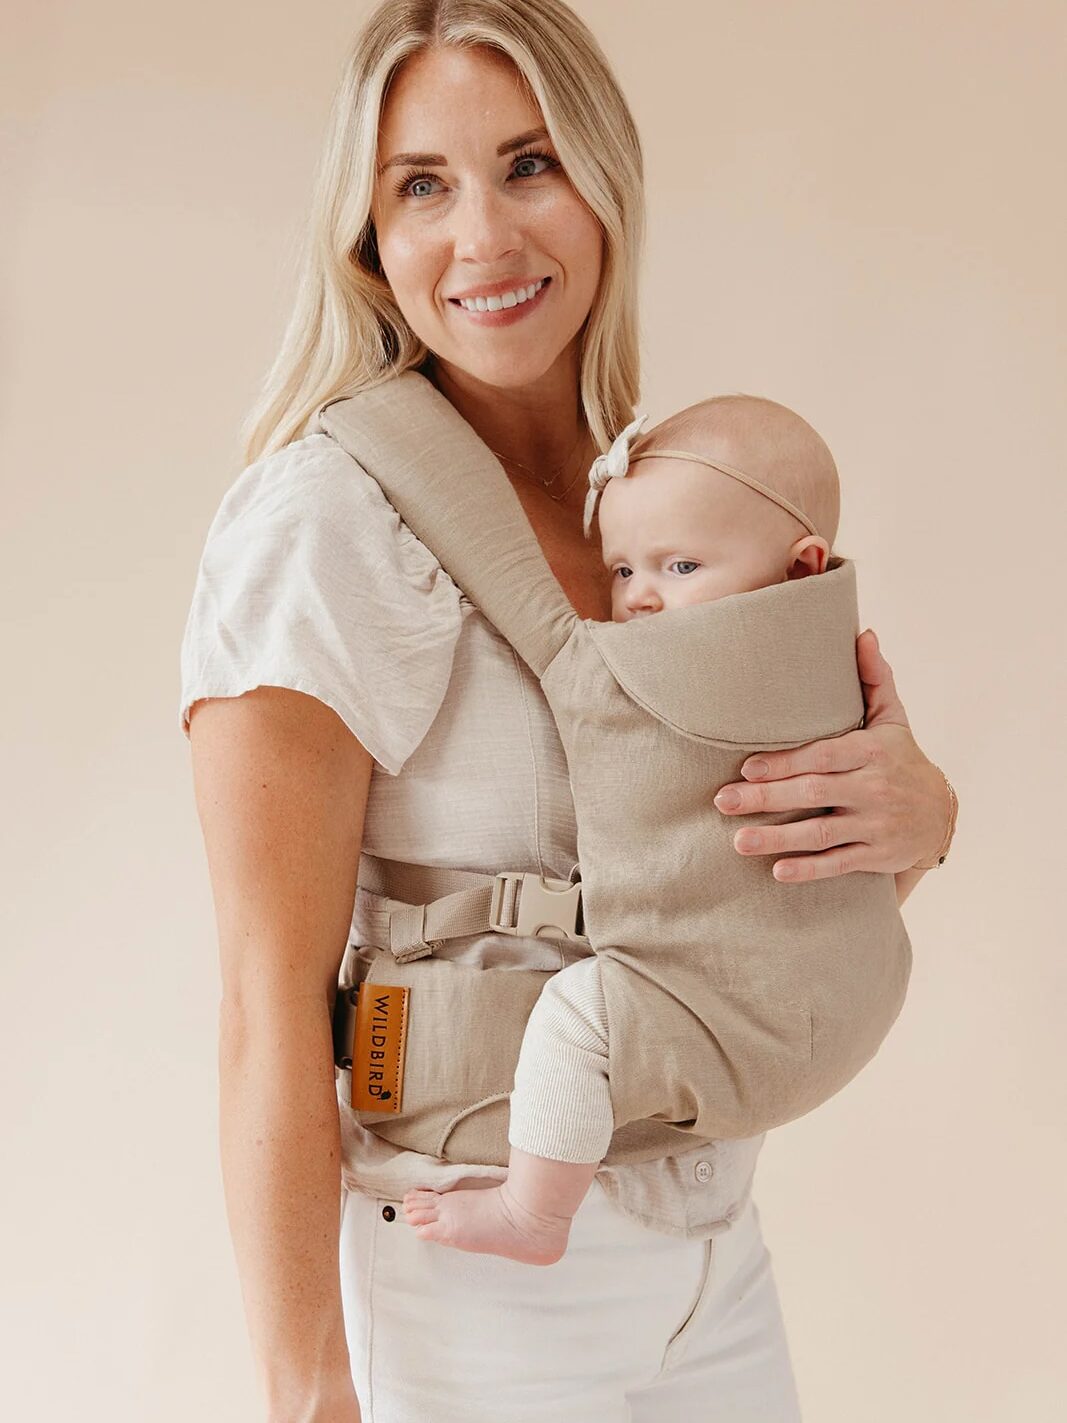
[{"xmin": 340, "ymin": 1181, "xmax": 800, "ymax": 1423}]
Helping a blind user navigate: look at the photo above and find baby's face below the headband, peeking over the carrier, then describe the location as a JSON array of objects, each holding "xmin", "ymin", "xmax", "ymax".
[{"xmin": 598, "ymin": 458, "xmax": 802, "ymax": 622}]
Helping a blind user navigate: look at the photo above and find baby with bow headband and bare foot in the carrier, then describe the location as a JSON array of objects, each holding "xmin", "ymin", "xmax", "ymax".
[{"xmin": 404, "ymin": 396, "xmax": 839, "ymax": 1265}]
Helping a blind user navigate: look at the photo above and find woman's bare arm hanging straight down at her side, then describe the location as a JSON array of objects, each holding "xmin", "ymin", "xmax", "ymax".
[{"xmin": 189, "ymin": 687, "xmax": 371, "ymax": 1423}]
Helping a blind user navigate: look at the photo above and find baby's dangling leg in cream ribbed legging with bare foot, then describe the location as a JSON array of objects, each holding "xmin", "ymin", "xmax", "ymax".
[{"xmin": 404, "ymin": 958, "xmax": 615, "ymax": 1265}]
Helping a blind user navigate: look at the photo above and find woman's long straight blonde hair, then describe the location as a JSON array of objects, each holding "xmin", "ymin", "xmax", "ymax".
[{"xmin": 242, "ymin": 0, "xmax": 644, "ymax": 464}]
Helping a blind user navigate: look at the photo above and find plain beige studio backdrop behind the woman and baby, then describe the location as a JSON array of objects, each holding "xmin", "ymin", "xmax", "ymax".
[{"xmin": 0, "ymin": 0, "xmax": 1067, "ymax": 1423}]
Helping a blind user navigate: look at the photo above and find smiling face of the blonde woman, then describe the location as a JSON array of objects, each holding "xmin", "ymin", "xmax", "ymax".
[{"xmin": 373, "ymin": 48, "xmax": 602, "ymax": 390}]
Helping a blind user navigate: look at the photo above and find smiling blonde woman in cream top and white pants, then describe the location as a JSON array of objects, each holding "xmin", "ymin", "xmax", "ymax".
[{"xmin": 182, "ymin": 0, "xmax": 949, "ymax": 1423}]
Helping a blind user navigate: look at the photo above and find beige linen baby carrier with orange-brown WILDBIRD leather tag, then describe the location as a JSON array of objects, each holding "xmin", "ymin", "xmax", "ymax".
[{"xmin": 319, "ymin": 371, "xmax": 911, "ymax": 1164}]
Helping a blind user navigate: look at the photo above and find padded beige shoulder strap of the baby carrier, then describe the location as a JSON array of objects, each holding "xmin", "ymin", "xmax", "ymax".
[{"xmin": 319, "ymin": 371, "xmax": 578, "ymax": 677}]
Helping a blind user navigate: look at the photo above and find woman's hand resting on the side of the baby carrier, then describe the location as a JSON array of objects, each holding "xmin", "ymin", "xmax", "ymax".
[{"xmin": 714, "ymin": 629, "xmax": 950, "ymax": 888}]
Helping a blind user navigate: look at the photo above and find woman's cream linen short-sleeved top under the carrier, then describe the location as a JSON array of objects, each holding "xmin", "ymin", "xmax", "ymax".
[{"xmin": 179, "ymin": 433, "xmax": 763, "ymax": 1238}]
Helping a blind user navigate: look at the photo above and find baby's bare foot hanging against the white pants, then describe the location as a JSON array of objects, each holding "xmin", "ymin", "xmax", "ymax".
[{"xmin": 404, "ymin": 1181, "xmax": 570, "ymax": 1265}]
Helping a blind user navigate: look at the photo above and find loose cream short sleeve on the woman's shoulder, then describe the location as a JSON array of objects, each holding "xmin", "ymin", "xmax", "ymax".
[{"xmin": 179, "ymin": 434, "xmax": 462, "ymax": 776}]
